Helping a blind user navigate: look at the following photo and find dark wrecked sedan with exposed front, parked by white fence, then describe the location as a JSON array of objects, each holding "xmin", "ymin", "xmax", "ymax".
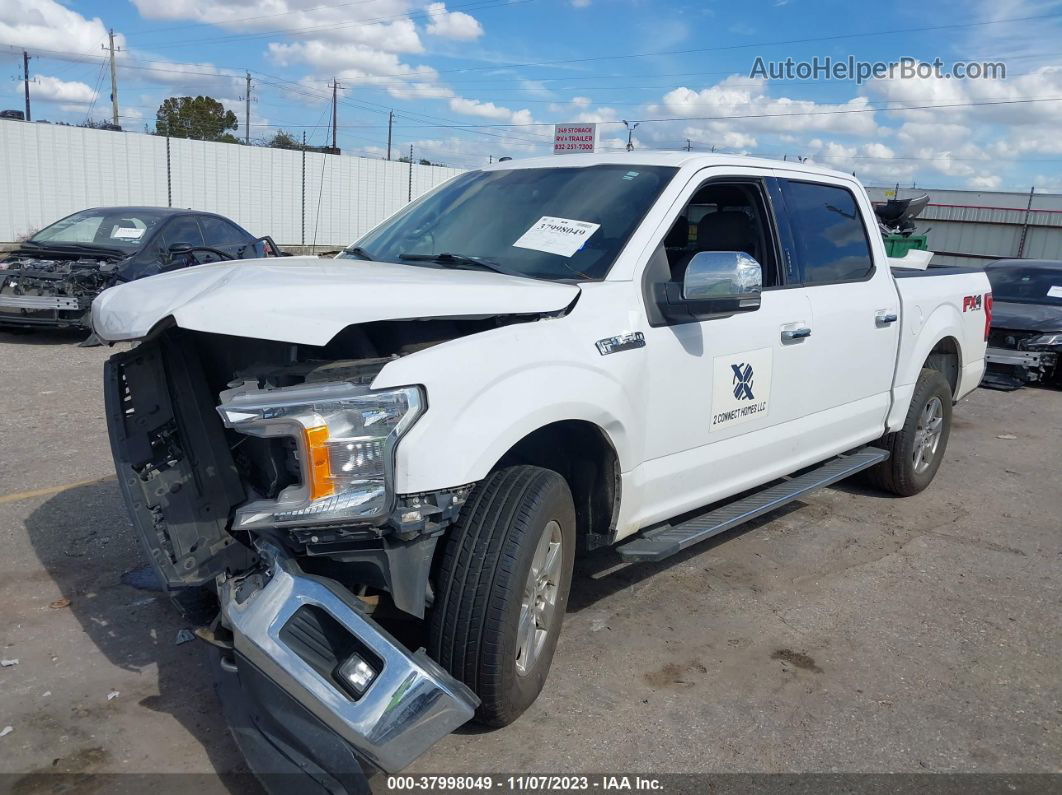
[{"xmin": 0, "ymin": 207, "xmax": 280, "ymax": 329}]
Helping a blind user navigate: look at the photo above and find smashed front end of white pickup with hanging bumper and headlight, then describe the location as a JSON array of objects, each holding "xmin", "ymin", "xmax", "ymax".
[{"xmin": 105, "ymin": 328, "xmax": 478, "ymax": 791}]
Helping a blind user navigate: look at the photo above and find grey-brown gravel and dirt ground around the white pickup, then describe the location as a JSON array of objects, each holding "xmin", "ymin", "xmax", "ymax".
[{"xmin": 0, "ymin": 326, "xmax": 1062, "ymax": 792}]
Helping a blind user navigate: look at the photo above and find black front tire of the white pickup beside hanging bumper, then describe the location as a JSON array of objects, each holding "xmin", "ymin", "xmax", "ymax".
[{"xmin": 428, "ymin": 466, "xmax": 576, "ymax": 726}]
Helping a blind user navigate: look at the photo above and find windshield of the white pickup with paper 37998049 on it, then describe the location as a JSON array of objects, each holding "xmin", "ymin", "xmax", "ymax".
[{"xmin": 341, "ymin": 166, "xmax": 676, "ymax": 280}]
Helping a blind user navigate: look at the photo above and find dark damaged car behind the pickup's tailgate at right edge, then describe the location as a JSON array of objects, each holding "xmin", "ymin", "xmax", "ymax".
[{"xmin": 984, "ymin": 259, "xmax": 1062, "ymax": 390}]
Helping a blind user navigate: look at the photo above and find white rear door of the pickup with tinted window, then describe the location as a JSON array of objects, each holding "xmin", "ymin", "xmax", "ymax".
[{"xmin": 775, "ymin": 170, "xmax": 901, "ymax": 451}]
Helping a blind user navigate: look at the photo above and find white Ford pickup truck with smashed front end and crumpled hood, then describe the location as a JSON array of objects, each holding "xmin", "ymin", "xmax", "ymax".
[{"xmin": 92, "ymin": 152, "xmax": 991, "ymax": 789}]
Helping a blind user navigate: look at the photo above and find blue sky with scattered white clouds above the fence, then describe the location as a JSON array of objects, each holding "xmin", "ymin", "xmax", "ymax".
[{"xmin": 0, "ymin": 0, "xmax": 1062, "ymax": 191}]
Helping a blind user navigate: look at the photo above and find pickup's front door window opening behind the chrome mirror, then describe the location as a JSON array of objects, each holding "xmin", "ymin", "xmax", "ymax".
[{"xmin": 664, "ymin": 182, "xmax": 781, "ymax": 288}]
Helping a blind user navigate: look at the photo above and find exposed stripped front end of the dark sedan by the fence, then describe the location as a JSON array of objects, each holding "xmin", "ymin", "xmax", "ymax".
[{"xmin": 0, "ymin": 248, "xmax": 125, "ymax": 329}]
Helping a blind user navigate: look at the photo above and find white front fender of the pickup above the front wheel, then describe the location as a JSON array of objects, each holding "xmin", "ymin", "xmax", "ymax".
[{"xmin": 373, "ymin": 319, "xmax": 645, "ymax": 494}]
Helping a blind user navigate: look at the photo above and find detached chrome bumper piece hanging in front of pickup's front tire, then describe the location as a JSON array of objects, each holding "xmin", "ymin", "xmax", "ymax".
[{"xmin": 220, "ymin": 548, "xmax": 479, "ymax": 773}]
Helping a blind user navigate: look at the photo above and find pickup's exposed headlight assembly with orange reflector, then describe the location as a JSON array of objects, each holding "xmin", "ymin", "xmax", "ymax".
[{"xmin": 218, "ymin": 382, "xmax": 425, "ymax": 530}]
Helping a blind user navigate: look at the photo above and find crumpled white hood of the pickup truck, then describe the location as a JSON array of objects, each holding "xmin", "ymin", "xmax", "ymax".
[{"xmin": 92, "ymin": 257, "xmax": 579, "ymax": 345}]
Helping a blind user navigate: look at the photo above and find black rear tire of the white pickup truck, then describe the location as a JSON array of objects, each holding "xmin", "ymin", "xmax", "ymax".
[{"xmin": 867, "ymin": 368, "xmax": 952, "ymax": 497}]
